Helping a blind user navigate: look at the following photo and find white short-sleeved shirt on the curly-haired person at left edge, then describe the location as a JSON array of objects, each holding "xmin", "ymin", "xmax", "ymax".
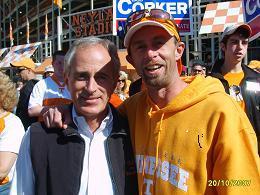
[{"xmin": 0, "ymin": 113, "xmax": 24, "ymax": 184}]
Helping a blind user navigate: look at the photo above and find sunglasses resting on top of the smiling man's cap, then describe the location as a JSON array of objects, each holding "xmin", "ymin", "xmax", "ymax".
[{"xmin": 126, "ymin": 9, "xmax": 172, "ymax": 31}]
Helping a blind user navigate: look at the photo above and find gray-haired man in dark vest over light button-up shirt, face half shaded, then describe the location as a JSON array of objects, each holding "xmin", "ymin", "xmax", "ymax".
[{"xmin": 11, "ymin": 37, "xmax": 138, "ymax": 195}]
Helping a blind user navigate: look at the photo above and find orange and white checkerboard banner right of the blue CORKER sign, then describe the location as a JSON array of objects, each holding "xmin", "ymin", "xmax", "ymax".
[{"xmin": 199, "ymin": 1, "xmax": 244, "ymax": 34}]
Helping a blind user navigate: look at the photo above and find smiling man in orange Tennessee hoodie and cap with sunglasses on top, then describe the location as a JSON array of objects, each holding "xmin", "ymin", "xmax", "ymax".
[{"xmin": 119, "ymin": 9, "xmax": 260, "ymax": 195}]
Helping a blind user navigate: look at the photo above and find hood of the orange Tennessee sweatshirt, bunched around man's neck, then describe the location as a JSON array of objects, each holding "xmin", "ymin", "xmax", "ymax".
[{"xmin": 147, "ymin": 75, "xmax": 225, "ymax": 113}]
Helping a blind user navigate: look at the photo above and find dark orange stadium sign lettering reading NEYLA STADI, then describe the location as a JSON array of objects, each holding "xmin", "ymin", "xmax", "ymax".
[{"xmin": 71, "ymin": 7, "xmax": 113, "ymax": 38}]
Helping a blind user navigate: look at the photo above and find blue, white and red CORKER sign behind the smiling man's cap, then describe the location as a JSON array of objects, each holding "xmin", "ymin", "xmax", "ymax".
[{"xmin": 113, "ymin": 0, "xmax": 193, "ymax": 37}]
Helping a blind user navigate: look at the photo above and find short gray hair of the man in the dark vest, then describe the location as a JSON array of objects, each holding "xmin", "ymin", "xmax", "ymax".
[{"xmin": 64, "ymin": 36, "xmax": 121, "ymax": 76}]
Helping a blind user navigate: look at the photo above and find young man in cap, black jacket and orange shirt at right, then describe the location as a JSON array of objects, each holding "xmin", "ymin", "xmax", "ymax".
[{"xmin": 211, "ymin": 24, "xmax": 260, "ymax": 148}]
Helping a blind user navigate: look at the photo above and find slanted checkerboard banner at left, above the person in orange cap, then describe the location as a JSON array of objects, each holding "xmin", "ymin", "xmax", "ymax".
[{"xmin": 0, "ymin": 42, "xmax": 42, "ymax": 67}]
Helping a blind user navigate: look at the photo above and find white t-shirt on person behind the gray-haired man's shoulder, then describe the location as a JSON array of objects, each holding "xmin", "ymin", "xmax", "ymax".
[{"xmin": 28, "ymin": 77, "xmax": 71, "ymax": 108}]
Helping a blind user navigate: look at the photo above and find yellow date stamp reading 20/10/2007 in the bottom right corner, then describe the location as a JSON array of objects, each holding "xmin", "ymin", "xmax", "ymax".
[{"xmin": 208, "ymin": 179, "xmax": 251, "ymax": 187}]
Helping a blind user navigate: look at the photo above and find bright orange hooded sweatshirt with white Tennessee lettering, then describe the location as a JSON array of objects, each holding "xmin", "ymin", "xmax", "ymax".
[{"xmin": 119, "ymin": 77, "xmax": 260, "ymax": 195}]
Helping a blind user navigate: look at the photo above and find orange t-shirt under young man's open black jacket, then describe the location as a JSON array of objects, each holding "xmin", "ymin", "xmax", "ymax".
[{"xmin": 224, "ymin": 72, "xmax": 245, "ymax": 111}]
